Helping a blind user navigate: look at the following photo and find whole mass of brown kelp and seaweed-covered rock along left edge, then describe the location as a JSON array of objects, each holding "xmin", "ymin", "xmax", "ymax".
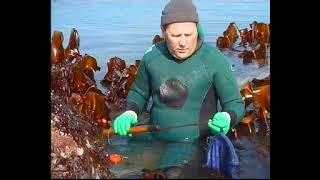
[{"xmin": 51, "ymin": 29, "xmax": 113, "ymax": 178}]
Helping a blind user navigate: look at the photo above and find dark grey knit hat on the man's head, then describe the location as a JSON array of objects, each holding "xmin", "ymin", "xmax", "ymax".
[{"xmin": 161, "ymin": 0, "xmax": 199, "ymax": 26}]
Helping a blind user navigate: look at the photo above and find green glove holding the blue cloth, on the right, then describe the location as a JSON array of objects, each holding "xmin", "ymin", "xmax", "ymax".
[{"xmin": 208, "ymin": 112, "xmax": 231, "ymax": 134}]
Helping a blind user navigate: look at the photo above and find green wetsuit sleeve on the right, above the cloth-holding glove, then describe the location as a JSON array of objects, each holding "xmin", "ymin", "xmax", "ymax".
[{"xmin": 213, "ymin": 55, "xmax": 245, "ymax": 128}]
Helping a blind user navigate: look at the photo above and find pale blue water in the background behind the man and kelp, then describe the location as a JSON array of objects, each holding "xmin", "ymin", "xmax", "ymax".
[{"xmin": 51, "ymin": 0, "xmax": 270, "ymax": 89}]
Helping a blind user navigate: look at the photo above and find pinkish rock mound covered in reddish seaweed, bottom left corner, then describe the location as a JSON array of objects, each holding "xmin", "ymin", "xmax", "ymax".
[{"xmin": 51, "ymin": 93, "xmax": 112, "ymax": 178}]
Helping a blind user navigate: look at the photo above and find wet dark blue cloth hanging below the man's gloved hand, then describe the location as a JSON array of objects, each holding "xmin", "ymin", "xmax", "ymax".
[{"xmin": 207, "ymin": 133, "xmax": 239, "ymax": 179}]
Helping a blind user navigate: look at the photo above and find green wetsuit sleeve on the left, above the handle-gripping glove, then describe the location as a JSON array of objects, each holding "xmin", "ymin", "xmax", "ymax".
[{"xmin": 126, "ymin": 58, "xmax": 150, "ymax": 115}]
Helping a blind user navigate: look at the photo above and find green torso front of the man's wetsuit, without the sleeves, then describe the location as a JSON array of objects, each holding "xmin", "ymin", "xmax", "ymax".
[{"xmin": 147, "ymin": 51, "xmax": 213, "ymax": 140}]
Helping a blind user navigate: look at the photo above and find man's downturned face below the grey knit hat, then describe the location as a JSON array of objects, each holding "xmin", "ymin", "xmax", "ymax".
[{"xmin": 162, "ymin": 22, "xmax": 198, "ymax": 60}]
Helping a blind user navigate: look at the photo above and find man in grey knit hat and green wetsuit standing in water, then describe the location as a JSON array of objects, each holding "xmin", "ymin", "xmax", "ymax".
[{"xmin": 113, "ymin": 0, "xmax": 244, "ymax": 177}]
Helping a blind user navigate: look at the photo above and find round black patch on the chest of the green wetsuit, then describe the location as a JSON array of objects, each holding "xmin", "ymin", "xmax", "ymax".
[{"xmin": 159, "ymin": 79, "xmax": 189, "ymax": 110}]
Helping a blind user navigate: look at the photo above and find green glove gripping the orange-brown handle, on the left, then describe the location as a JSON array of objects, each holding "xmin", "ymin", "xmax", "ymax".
[{"xmin": 113, "ymin": 111, "xmax": 138, "ymax": 136}]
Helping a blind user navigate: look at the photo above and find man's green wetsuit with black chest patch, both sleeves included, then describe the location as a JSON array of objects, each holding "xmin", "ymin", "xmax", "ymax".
[{"xmin": 126, "ymin": 40, "xmax": 244, "ymax": 168}]
